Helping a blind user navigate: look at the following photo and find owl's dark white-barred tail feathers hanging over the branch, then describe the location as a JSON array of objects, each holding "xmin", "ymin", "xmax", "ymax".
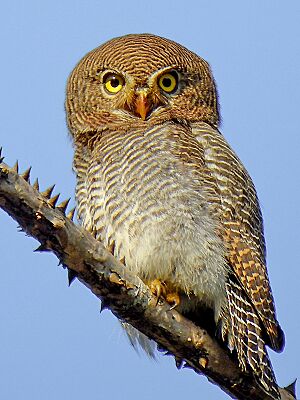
[{"xmin": 226, "ymin": 276, "xmax": 280, "ymax": 400}]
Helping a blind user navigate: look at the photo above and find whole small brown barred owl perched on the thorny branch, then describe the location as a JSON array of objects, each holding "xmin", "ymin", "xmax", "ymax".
[{"xmin": 66, "ymin": 34, "xmax": 284, "ymax": 399}]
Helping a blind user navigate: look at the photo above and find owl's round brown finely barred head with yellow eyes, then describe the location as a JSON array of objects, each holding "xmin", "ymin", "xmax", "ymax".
[{"xmin": 66, "ymin": 34, "xmax": 219, "ymax": 136}]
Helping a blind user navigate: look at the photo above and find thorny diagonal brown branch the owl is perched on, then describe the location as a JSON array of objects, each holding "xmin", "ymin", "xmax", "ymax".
[{"xmin": 0, "ymin": 154, "xmax": 295, "ymax": 400}]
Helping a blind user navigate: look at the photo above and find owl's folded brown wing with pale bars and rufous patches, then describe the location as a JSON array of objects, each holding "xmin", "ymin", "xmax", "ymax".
[{"xmin": 193, "ymin": 123, "xmax": 284, "ymax": 351}]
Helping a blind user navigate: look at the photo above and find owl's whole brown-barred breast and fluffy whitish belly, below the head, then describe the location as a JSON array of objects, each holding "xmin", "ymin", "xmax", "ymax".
[{"xmin": 75, "ymin": 123, "xmax": 227, "ymax": 318}]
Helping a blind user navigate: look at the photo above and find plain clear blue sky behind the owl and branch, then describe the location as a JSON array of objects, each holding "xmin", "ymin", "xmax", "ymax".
[{"xmin": 0, "ymin": 0, "xmax": 300, "ymax": 400}]
